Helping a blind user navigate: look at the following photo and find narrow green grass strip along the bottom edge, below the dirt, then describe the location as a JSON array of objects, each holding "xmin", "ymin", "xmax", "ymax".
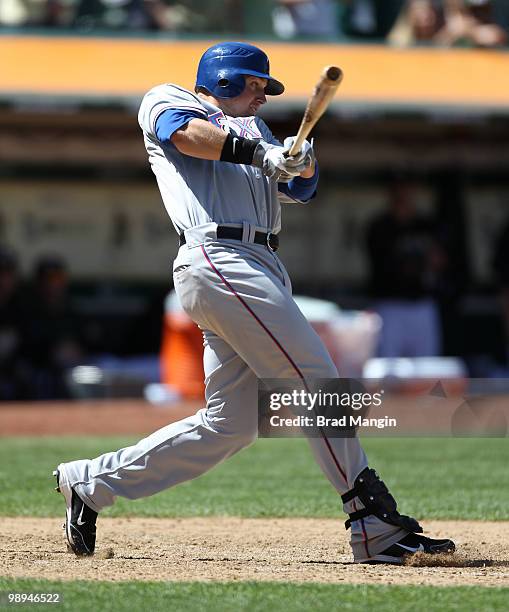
[{"xmin": 0, "ymin": 578, "xmax": 509, "ymax": 612}]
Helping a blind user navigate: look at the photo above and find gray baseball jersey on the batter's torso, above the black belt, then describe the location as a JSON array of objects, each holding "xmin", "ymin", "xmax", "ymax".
[{"xmin": 138, "ymin": 85, "xmax": 294, "ymax": 233}]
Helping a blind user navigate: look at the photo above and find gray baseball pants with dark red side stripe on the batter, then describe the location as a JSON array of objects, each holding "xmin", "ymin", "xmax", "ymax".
[{"xmin": 62, "ymin": 224, "xmax": 406, "ymax": 560}]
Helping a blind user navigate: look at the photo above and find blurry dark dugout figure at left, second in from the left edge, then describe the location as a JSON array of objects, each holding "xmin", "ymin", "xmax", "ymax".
[{"xmin": 23, "ymin": 256, "xmax": 83, "ymax": 399}]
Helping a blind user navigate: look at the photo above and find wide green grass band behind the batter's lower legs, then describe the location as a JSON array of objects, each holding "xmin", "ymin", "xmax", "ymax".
[{"xmin": 0, "ymin": 437, "xmax": 509, "ymax": 520}]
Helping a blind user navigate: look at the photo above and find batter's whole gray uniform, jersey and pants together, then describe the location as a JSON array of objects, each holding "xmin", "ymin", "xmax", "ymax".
[{"xmin": 58, "ymin": 85, "xmax": 405, "ymax": 561}]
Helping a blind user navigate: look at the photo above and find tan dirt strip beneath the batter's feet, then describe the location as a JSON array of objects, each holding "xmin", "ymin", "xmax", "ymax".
[{"xmin": 0, "ymin": 517, "xmax": 509, "ymax": 586}]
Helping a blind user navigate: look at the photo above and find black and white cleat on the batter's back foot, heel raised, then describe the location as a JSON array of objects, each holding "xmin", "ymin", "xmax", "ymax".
[{"xmin": 53, "ymin": 463, "xmax": 97, "ymax": 557}]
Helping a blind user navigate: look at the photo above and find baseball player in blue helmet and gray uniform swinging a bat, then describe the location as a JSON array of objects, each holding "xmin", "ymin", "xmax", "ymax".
[{"xmin": 55, "ymin": 42, "xmax": 454, "ymax": 564}]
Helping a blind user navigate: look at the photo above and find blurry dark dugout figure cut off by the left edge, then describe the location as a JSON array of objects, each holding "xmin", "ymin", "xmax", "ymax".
[{"xmin": 0, "ymin": 247, "xmax": 25, "ymax": 400}]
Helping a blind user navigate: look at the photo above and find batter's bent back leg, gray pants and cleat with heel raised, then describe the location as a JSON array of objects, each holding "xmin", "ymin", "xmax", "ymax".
[{"xmin": 57, "ymin": 332, "xmax": 258, "ymax": 555}]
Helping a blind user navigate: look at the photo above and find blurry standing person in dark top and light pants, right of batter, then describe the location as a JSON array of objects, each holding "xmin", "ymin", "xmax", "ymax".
[{"xmin": 367, "ymin": 181, "xmax": 445, "ymax": 357}]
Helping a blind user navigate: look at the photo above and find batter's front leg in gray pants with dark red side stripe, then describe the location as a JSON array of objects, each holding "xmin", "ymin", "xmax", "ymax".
[{"xmin": 191, "ymin": 245, "xmax": 424, "ymax": 559}]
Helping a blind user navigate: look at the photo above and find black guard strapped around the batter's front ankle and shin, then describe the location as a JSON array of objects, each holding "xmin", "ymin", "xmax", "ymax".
[{"xmin": 341, "ymin": 468, "xmax": 422, "ymax": 533}]
